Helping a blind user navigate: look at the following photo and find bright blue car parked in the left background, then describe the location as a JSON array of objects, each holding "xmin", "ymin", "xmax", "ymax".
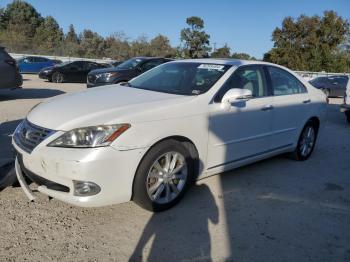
[{"xmin": 17, "ymin": 56, "xmax": 56, "ymax": 73}]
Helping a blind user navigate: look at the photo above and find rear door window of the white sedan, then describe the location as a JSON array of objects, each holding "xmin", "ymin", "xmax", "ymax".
[{"xmin": 268, "ymin": 66, "xmax": 307, "ymax": 96}]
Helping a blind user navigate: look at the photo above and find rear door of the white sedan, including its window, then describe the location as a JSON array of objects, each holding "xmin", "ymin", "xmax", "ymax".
[{"xmin": 266, "ymin": 66, "xmax": 312, "ymax": 149}]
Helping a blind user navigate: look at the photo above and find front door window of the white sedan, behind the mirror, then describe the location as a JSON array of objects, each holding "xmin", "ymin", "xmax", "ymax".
[{"xmin": 214, "ymin": 66, "xmax": 266, "ymax": 103}]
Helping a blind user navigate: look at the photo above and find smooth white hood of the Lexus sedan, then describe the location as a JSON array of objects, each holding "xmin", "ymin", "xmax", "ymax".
[{"xmin": 27, "ymin": 85, "xmax": 196, "ymax": 131}]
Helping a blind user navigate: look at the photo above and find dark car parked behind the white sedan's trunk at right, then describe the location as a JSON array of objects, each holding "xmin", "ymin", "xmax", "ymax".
[{"xmin": 309, "ymin": 75, "xmax": 349, "ymax": 96}]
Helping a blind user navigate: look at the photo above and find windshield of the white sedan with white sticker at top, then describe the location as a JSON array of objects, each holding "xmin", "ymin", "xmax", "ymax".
[{"xmin": 129, "ymin": 62, "xmax": 230, "ymax": 95}]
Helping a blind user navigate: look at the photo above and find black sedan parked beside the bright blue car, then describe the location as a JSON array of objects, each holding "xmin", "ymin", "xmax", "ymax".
[{"xmin": 39, "ymin": 61, "xmax": 107, "ymax": 83}]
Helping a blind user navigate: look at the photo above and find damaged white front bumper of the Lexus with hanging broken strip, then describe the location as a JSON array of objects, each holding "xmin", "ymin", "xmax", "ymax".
[{"xmin": 13, "ymin": 142, "xmax": 146, "ymax": 207}]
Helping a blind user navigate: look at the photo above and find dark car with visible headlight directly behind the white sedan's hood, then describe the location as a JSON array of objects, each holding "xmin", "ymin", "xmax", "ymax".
[{"xmin": 87, "ymin": 57, "xmax": 172, "ymax": 88}]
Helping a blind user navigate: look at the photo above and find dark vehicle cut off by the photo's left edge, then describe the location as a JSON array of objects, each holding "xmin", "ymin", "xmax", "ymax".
[{"xmin": 0, "ymin": 46, "xmax": 23, "ymax": 88}]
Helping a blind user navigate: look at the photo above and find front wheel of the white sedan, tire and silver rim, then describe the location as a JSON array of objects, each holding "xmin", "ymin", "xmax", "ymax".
[{"xmin": 132, "ymin": 139, "xmax": 195, "ymax": 212}]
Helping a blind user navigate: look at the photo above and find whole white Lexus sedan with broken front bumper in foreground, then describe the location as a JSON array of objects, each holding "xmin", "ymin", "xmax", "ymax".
[{"xmin": 13, "ymin": 59, "xmax": 326, "ymax": 211}]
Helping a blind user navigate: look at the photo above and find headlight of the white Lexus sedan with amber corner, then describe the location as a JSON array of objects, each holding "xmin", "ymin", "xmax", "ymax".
[{"xmin": 48, "ymin": 124, "xmax": 130, "ymax": 148}]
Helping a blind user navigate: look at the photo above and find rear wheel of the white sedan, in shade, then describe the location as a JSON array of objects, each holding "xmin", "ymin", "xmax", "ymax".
[{"xmin": 291, "ymin": 120, "xmax": 318, "ymax": 161}]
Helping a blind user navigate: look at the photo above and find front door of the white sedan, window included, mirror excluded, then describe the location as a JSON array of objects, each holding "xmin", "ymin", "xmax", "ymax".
[{"xmin": 207, "ymin": 65, "xmax": 272, "ymax": 169}]
